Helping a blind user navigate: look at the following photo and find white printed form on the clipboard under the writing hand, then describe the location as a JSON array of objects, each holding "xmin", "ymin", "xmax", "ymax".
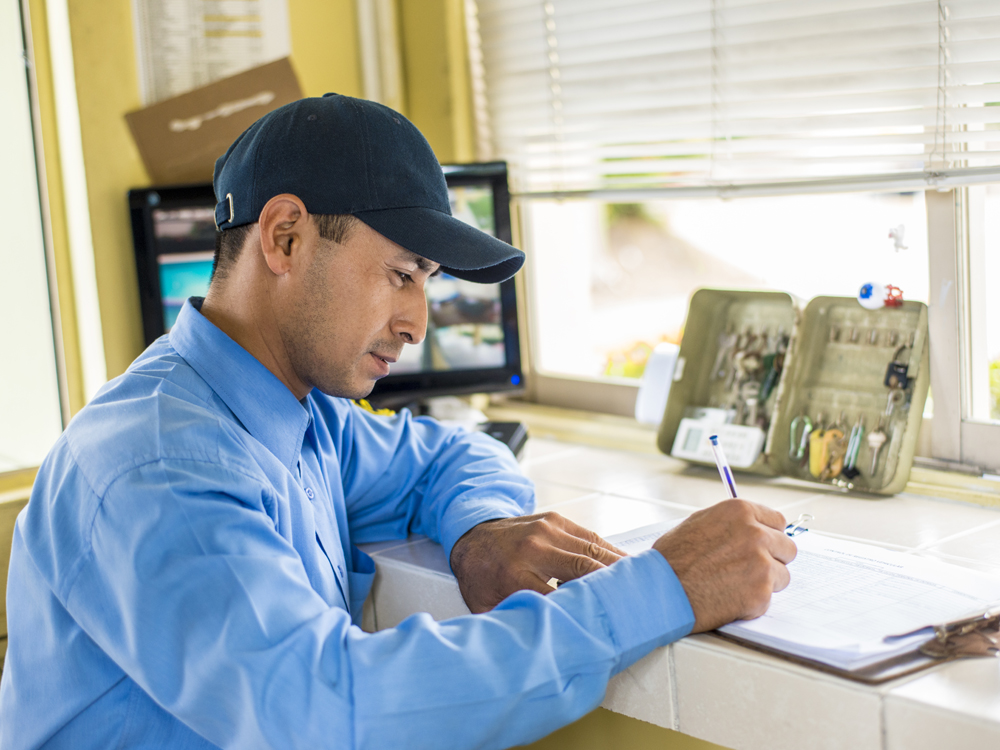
[{"xmin": 608, "ymin": 522, "xmax": 1000, "ymax": 670}]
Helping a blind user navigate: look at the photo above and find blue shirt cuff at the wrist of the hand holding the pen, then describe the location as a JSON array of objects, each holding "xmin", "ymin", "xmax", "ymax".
[{"xmin": 579, "ymin": 550, "xmax": 694, "ymax": 671}]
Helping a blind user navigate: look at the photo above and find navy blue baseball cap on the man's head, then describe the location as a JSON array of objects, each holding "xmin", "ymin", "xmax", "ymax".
[{"xmin": 213, "ymin": 94, "xmax": 524, "ymax": 284}]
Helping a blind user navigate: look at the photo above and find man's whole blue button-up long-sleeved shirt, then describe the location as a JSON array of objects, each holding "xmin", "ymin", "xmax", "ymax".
[{"xmin": 0, "ymin": 302, "xmax": 693, "ymax": 750}]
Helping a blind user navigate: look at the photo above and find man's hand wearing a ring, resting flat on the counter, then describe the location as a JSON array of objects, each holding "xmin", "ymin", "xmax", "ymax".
[{"xmin": 451, "ymin": 513, "xmax": 625, "ymax": 612}]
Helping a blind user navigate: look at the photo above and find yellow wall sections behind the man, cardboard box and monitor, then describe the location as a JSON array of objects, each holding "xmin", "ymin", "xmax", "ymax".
[{"xmin": 30, "ymin": 0, "xmax": 472, "ymax": 388}]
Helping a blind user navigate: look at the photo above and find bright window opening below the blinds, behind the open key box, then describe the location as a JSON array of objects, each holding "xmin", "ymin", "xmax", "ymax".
[{"xmin": 522, "ymin": 191, "xmax": 929, "ymax": 378}]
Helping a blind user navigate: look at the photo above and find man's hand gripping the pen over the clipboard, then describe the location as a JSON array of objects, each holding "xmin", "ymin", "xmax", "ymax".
[{"xmin": 653, "ymin": 500, "xmax": 797, "ymax": 633}]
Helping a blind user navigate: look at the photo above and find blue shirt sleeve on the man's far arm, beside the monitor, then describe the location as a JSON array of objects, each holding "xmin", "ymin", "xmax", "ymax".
[{"xmin": 316, "ymin": 397, "xmax": 535, "ymax": 559}]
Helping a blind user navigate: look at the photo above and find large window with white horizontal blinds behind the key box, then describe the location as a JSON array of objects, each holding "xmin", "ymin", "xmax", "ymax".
[{"xmin": 467, "ymin": 0, "xmax": 1000, "ymax": 467}]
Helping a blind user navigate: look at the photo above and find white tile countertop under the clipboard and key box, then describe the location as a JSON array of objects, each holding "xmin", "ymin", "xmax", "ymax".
[{"xmin": 365, "ymin": 438, "xmax": 1000, "ymax": 750}]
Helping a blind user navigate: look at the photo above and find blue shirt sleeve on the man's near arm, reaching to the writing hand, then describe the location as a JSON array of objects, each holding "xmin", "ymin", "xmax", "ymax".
[{"xmin": 59, "ymin": 460, "xmax": 694, "ymax": 750}]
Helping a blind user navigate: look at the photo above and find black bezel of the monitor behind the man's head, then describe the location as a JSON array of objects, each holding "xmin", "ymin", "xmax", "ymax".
[{"xmin": 128, "ymin": 162, "xmax": 524, "ymax": 406}]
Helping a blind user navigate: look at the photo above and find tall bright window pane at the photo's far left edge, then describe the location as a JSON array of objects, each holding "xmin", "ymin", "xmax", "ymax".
[{"xmin": 0, "ymin": 3, "xmax": 62, "ymax": 473}]
